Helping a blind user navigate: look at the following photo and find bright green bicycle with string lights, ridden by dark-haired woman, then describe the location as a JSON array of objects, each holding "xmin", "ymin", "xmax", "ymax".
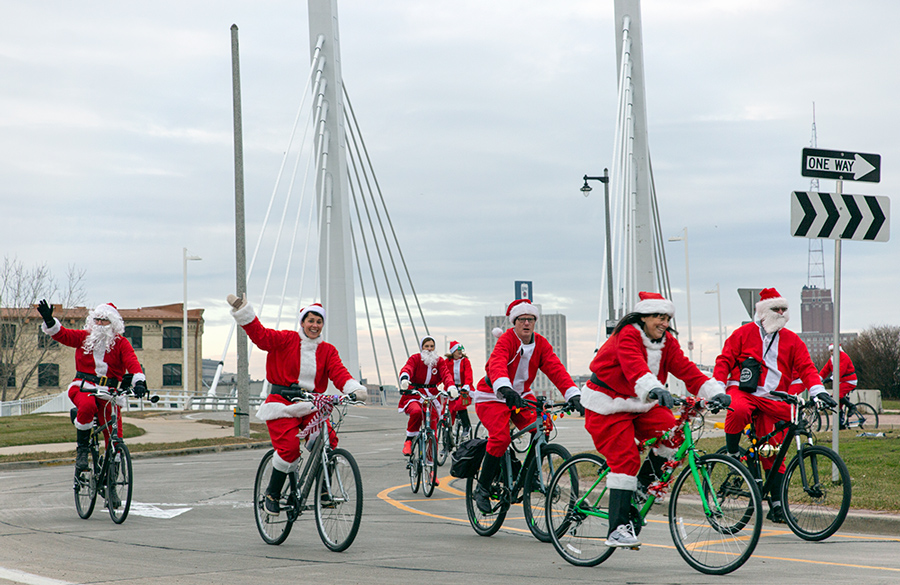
[{"xmin": 546, "ymin": 397, "xmax": 762, "ymax": 575}]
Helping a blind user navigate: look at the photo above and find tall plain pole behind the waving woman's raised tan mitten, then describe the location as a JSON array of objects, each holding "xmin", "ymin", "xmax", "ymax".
[{"xmin": 231, "ymin": 24, "xmax": 250, "ymax": 437}]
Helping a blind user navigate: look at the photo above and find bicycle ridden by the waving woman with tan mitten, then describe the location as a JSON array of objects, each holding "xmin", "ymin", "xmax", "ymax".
[{"xmin": 253, "ymin": 386, "xmax": 364, "ymax": 552}]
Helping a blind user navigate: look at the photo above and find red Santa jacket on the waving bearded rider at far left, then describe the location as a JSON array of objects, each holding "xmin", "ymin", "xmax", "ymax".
[{"xmin": 42, "ymin": 319, "xmax": 147, "ymax": 388}]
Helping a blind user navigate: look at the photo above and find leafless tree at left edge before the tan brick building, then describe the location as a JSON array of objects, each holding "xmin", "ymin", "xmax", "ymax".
[{"xmin": 0, "ymin": 256, "xmax": 85, "ymax": 401}]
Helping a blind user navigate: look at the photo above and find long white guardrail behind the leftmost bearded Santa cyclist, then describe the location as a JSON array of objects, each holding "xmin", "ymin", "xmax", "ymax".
[{"xmin": 0, "ymin": 391, "xmax": 262, "ymax": 417}]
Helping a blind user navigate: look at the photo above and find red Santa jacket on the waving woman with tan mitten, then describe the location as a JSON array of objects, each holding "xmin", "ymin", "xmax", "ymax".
[{"xmin": 235, "ymin": 314, "xmax": 364, "ymax": 421}]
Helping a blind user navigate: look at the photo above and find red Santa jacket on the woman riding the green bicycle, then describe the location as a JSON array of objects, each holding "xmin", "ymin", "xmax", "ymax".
[{"xmin": 581, "ymin": 324, "xmax": 723, "ymax": 414}]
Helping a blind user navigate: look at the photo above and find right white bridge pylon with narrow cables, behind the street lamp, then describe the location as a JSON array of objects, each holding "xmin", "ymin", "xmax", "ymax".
[{"xmin": 597, "ymin": 0, "xmax": 672, "ymax": 347}]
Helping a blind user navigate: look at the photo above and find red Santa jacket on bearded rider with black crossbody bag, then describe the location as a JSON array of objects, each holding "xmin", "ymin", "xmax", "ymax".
[{"xmin": 713, "ymin": 321, "xmax": 826, "ymax": 396}]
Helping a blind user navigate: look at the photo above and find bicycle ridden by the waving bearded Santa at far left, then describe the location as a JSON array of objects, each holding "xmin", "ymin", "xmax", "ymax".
[{"xmin": 69, "ymin": 374, "xmax": 159, "ymax": 524}]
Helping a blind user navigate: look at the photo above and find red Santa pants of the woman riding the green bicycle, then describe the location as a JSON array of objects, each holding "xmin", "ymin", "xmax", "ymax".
[{"xmin": 584, "ymin": 406, "xmax": 680, "ymax": 477}]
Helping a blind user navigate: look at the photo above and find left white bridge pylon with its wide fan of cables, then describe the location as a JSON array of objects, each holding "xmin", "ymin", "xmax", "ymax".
[{"xmin": 208, "ymin": 0, "xmax": 428, "ymax": 396}]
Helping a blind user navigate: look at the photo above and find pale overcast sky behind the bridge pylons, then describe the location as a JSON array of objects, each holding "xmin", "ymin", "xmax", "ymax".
[{"xmin": 0, "ymin": 0, "xmax": 900, "ymax": 378}]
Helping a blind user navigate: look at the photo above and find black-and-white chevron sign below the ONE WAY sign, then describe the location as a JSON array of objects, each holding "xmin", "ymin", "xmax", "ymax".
[{"xmin": 791, "ymin": 191, "xmax": 891, "ymax": 242}]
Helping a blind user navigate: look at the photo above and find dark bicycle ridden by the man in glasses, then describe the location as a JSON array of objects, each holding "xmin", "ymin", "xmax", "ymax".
[{"xmin": 466, "ymin": 396, "xmax": 571, "ymax": 542}]
